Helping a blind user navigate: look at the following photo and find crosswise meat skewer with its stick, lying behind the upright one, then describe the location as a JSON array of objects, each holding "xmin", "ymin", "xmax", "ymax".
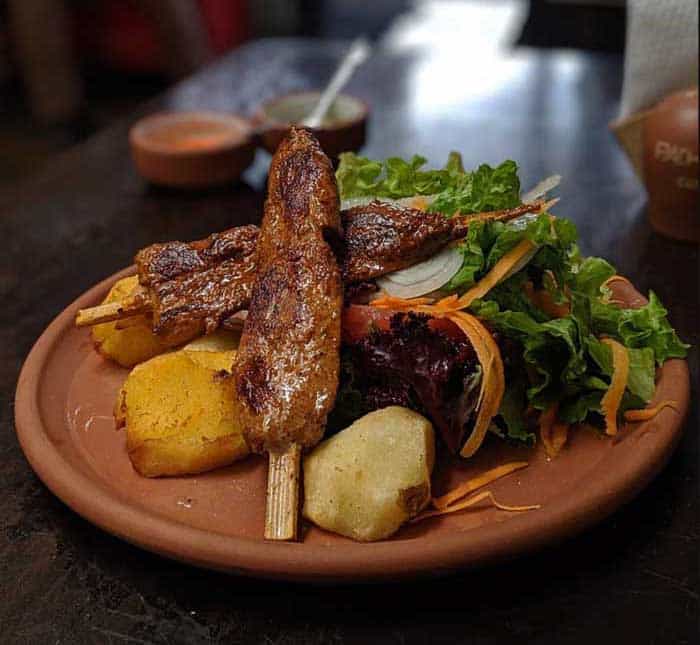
[{"xmin": 76, "ymin": 202, "xmax": 545, "ymax": 346}]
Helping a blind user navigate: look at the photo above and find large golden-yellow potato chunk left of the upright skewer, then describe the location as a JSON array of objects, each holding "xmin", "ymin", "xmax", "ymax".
[{"xmin": 115, "ymin": 344, "xmax": 248, "ymax": 477}]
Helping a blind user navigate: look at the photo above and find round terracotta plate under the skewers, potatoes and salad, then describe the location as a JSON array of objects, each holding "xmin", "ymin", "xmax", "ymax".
[{"xmin": 16, "ymin": 270, "xmax": 689, "ymax": 581}]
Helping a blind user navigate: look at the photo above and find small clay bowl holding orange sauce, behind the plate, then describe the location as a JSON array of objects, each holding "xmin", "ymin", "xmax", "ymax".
[{"xmin": 129, "ymin": 112, "xmax": 255, "ymax": 188}]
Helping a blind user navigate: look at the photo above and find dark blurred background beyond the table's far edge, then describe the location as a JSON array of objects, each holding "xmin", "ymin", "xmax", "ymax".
[{"xmin": 0, "ymin": 0, "xmax": 626, "ymax": 185}]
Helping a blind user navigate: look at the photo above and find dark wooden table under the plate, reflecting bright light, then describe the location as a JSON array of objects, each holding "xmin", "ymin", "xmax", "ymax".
[{"xmin": 0, "ymin": 41, "xmax": 698, "ymax": 645}]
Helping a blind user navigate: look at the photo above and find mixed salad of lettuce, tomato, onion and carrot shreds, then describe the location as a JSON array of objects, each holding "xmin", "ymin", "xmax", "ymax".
[{"xmin": 330, "ymin": 152, "xmax": 688, "ymax": 454}]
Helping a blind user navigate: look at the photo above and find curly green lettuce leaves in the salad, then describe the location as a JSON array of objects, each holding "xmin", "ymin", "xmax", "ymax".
[{"xmin": 337, "ymin": 153, "xmax": 689, "ymax": 443}]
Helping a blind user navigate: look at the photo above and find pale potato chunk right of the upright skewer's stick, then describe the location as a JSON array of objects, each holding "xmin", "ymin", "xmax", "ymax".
[{"xmin": 304, "ymin": 406, "xmax": 435, "ymax": 542}]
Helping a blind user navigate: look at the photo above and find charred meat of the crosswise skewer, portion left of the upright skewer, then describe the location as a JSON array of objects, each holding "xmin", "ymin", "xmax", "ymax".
[{"xmin": 136, "ymin": 226, "xmax": 259, "ymax": 345}]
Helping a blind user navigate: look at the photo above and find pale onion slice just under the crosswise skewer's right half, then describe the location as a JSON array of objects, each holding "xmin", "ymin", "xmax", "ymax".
[{"xmin": 377, "ymin": 246, "xmax": 462, "ymax": 298}]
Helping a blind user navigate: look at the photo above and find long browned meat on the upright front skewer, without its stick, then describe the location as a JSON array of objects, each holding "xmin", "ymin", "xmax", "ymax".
[{"xmin": 235, "ymin": 129, "xmax": 343, "ymax": 452}]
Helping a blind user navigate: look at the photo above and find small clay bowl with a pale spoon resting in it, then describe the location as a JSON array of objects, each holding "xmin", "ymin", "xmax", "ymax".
[{"xmin": 254, "ymin": 92, "xmax": 369, "ymax": 161}]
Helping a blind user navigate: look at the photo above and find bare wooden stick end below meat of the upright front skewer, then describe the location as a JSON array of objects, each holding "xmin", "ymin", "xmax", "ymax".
[{"xmin": 265, "ymin": 443, "xmax": 301, "ymax": 540}]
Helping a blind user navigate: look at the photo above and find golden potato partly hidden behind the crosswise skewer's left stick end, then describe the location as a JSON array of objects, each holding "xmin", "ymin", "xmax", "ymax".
[{"xmin": 91, "ymin": 275, "xmax": 169, "ymax": 367}]
